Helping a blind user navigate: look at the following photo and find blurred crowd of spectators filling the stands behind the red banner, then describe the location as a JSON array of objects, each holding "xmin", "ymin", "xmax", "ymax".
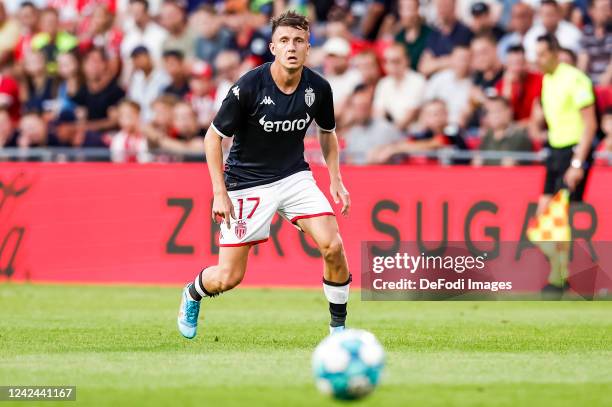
[{"xmin": 0, "ymin": 0, "xmax": 612, "ymax": 165}]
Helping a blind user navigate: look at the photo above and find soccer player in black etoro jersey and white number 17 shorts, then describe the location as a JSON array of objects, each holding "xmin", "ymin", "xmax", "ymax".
[{"xmin": 178, "ymin": 11, "xmax": 351, "ymax": 339}]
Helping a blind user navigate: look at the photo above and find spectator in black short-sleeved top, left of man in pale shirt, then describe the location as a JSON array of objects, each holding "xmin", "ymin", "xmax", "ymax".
[{"xmin": 74, "ymin": 48, "xmax": 125, "ymax": 131}]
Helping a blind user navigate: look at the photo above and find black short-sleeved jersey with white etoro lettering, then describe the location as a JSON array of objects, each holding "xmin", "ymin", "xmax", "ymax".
[{"xmin": 212, "ymin": 63, "xmax": 336, "ymax": 191}]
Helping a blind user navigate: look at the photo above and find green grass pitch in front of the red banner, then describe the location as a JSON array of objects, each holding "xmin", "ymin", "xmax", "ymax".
[{"xmin": 0, "ymin": 284, "xmax": 612, "ymax": 407}]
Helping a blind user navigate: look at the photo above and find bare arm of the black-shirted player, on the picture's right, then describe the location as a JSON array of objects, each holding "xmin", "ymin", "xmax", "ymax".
[{"xmin": 319, "ymin": 128, "xmax": 351, "ymax": 216}]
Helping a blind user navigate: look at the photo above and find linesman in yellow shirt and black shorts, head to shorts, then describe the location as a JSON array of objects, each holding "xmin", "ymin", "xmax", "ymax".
[{"xmin": 536, "ymin": 34, "xmax": 597, "ymax": 213}]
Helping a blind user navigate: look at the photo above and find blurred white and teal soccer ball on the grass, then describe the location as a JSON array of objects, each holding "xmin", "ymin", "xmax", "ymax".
[{"xmin": 312, "ymin": 329, "xmax": 385, "ymax": 400}]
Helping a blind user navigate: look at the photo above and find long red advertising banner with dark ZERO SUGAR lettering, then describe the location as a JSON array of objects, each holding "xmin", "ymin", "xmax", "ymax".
[{"xmin": 0, "ymin": 163, "xmax": 612, "ymax": 286}]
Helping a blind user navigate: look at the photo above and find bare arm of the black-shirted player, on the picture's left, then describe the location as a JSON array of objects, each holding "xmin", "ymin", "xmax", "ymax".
[{"xmin": 204, "ymin": 126, "xmax": 236, "ymax": 229}]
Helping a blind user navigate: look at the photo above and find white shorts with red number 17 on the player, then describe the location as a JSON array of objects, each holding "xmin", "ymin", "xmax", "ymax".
[{"xmin": 219, "ymin": 171, "xmax": 334, "ymax": 247}]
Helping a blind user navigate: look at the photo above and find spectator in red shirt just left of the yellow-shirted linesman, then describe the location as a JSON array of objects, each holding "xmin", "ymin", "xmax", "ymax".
[{"xmin": 495, "ymin": 45, "xmax": 542, "ymax": 124}]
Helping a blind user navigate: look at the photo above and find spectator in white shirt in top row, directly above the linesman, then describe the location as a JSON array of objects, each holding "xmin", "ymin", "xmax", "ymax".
[{"xmin": 523, "ymin": 0, "xmax": 582, "ymax": 63}]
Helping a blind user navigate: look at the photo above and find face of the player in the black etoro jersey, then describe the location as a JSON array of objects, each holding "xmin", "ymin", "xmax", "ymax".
[{"xmin": 270, "ymin": 27, "xmax": 310, "ymax": 70}]
